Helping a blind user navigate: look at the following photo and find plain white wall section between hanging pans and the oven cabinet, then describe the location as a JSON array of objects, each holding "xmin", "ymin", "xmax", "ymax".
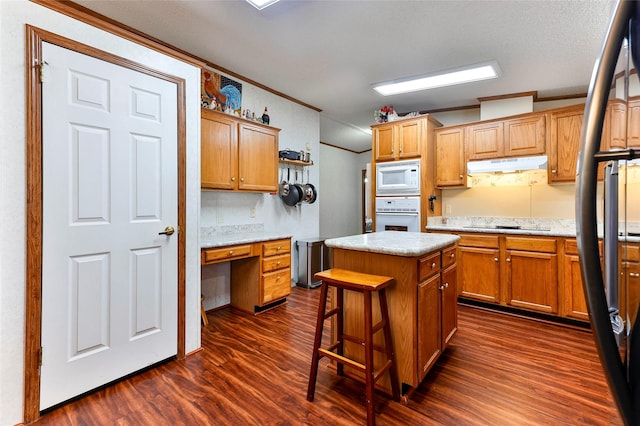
[{"xmin": 319, "ymin": 144, "xmax": 371, "ymax": 238}]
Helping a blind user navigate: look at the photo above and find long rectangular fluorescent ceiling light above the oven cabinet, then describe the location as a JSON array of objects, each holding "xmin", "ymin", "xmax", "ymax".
[{"xmin": 372, "ymin": 61, "xmax": 501, "ymax": 96}]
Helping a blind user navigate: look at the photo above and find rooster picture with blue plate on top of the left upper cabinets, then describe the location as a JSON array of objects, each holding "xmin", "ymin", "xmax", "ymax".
[{"xmin": 200, "ymin": 68, "xmax": 242, "ymax": 115}]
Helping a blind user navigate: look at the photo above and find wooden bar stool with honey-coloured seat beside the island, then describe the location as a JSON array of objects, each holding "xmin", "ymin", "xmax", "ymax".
[{"xmin": 307, "ymin": 268, "xmax": 400, "ymax": 425}]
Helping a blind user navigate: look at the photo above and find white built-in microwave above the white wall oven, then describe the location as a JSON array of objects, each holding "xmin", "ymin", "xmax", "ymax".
[{"xmin": 376, "ymin": 160, "xmax": 420, "ymax": 197}]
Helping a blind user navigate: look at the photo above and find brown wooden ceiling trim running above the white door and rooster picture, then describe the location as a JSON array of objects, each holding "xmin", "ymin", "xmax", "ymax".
[{"xmin": 30, "ymin": 0, "xmax": 322, "ymax": 112}]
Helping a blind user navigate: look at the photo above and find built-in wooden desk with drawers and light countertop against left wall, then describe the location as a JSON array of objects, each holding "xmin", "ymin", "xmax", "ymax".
[{"xmin": 200, "ymin": 234, "xmax": 291, "ymax": 313}]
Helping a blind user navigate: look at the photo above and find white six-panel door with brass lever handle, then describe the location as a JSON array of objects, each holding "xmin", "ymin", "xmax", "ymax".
[{"xmin": 40, "ymin": 43, "xmax": 178, "ymax": 409}]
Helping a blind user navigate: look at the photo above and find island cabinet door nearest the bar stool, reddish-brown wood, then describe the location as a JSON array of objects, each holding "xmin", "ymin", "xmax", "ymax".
[{"xmin": 418, "ymin": 274, "xmax": 442, "ymax": 382}]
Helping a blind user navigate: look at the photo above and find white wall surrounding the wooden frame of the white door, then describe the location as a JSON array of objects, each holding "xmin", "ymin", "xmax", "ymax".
[{"xmin": 0, "ymin": 0, "xmax": 200, "ymax": 425}]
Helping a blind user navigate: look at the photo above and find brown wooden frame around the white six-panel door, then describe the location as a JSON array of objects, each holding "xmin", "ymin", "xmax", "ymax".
[{"xmin": 23, "ymin": 25, "xmax": 187, "ymax": 424}]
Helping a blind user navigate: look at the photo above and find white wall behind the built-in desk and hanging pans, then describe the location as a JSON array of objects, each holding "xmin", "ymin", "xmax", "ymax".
[{"xmin": 201, "ymin": 80, "xmax": 323, "ymax": 310}]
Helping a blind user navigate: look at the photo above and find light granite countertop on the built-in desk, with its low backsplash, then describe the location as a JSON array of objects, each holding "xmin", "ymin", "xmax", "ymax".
[{"xmin": 200, "ymin": 224, "xmax": 292, "ymax": 249}]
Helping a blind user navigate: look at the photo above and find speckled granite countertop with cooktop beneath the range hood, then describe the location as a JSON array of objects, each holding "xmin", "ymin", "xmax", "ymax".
[{"xmin": 426, "ymin": 216, "xmax": 602, "ymax": 237}]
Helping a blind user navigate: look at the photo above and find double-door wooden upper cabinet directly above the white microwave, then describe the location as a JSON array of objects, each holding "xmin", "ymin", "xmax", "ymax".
[{"xmin": 373, "ymin": 118, "xmax": 423, "ymax": 161}]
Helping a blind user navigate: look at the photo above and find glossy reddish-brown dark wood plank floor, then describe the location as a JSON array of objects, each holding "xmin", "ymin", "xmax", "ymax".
[{"xmin": 36, "ymin": 288, "xmax": 622, "ymax": 425}]
